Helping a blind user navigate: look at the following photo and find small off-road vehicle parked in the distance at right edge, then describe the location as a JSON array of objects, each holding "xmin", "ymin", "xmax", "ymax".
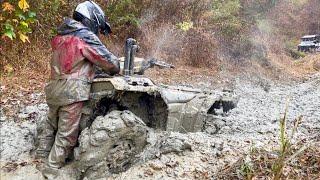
[{"xmin": 298, "ymin": 35, "xmax": 320, "ymax": 52}]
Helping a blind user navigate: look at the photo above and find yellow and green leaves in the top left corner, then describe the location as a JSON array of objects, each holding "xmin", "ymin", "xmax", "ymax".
[{"xmin": 0, "ymin": 0, "xmax": 36, "ymax": 42}]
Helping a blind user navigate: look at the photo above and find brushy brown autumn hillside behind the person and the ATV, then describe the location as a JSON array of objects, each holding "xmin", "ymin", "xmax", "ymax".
[{"xmin": 0, "ymin": 0, "xmax": 320, "ymax": 76}]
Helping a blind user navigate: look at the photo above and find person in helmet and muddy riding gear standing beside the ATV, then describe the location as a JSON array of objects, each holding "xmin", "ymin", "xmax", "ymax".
[{"xmin": 36, "ymin": 1, "xmax": 119, "ymax": 178}]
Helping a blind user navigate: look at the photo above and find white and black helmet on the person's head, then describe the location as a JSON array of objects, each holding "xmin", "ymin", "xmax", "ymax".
[{"xmin": 73, "ymin": 1, "xmax": 112, "ymax": 35}]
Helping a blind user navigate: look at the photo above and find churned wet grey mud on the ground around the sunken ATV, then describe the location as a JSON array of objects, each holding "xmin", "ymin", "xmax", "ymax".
[{"xmin": 0, "ymin": 74, "xmax": 320, "ymax": 179}]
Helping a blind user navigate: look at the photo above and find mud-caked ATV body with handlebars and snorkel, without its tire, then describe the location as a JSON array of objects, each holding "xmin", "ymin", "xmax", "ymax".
[{"xmin": 86, "ymin": 39, "xmax": 235, "ymax": 133}]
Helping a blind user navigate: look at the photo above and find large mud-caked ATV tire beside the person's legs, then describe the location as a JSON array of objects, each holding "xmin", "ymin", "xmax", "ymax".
[{"xmin": 75, "ymin": 111, "xmax": 148, "ymax": 179}]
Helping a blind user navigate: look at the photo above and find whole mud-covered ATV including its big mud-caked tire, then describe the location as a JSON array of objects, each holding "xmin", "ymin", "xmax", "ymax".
[{"xmin": 67, "ymin": 39, "xmax": 236, "ymax": 179}]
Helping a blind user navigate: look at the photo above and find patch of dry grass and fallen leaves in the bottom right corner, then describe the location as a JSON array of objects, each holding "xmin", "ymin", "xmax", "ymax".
[{"xmin": 216, "ymin": 105, "xmax": 320, "ymax": 180}]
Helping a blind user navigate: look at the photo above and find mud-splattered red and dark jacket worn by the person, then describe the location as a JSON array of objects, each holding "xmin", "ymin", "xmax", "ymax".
[{"xmin": 45, "ymin": 18, "xmax": 119, "ymax": 105}]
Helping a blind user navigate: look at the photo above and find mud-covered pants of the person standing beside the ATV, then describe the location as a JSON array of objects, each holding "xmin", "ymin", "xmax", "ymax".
[{"xmin": 36, "ymin": 102, "xmax": 88, "ymax": 168}]
